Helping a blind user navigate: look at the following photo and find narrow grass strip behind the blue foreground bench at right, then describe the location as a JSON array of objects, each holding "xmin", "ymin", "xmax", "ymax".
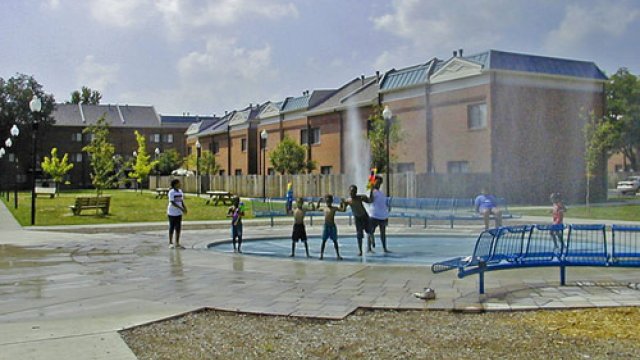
[{"xmin": 517, "ymin": 204, "xmax": 640, "ymax": 221}]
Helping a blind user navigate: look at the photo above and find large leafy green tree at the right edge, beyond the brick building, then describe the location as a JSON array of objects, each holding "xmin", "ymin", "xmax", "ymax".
[{"xmin": 604, "ymin": 68, "xmax": 640, "ymax": 170}]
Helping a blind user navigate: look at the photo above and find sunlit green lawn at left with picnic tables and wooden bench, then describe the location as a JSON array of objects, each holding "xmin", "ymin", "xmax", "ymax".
[{"xmin": 2, "ymin": 190, "xmax": 251, "ymax": 226}]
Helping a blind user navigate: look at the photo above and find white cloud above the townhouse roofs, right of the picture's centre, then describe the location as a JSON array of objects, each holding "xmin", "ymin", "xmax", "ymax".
[{"xmin": 372, "ymin": 0, "xmax": 527, "ymax": 69}]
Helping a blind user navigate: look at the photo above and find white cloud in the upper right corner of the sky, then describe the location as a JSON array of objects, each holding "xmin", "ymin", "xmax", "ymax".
[{"xmin": 545, "ymin": 1, "xmax": 640, "ymax": 54}]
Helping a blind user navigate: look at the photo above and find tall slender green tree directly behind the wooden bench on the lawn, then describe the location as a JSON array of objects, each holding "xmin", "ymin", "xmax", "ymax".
[{"xmin": 82, "ymin": 115, "xmax": 118, "ymax": 196}]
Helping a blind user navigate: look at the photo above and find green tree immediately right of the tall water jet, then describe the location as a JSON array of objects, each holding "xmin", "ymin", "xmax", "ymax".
[{"xmin": 367, "ymin": 105, "xmax": 402, "ymax": 173}]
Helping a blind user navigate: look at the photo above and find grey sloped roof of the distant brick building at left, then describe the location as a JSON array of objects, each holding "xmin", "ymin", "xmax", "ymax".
[{"xmin": 52, "ymin": 104, "xmax": 160, "ymax": 128}]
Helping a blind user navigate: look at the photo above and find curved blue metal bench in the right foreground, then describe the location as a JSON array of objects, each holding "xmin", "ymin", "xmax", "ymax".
[{"xmin": 431, "ymin": 224, "xmax": 640, "ymax": 294}]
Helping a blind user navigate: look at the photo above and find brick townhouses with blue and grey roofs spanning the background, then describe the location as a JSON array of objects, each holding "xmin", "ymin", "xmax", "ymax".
[{"xmin": 0, "ymin": 50, "xmax": 607, "ymax": 201}]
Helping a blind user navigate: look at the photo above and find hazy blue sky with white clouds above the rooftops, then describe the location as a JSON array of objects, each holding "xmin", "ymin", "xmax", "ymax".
[{"xmin": 0, "ymin": 0, "xmax": 640, "ymax": 115}]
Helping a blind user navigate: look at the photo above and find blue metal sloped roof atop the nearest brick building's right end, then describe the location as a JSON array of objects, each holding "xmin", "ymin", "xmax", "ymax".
[{"xmin": 465, "ymin": 50, "xmax": 607, "ymax": 80}]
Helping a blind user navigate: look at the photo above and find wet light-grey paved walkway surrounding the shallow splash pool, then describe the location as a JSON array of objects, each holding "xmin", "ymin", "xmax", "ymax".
[{"xmin": 0, "ymin": 204, "xmax": 640, "ymax": 359}]
